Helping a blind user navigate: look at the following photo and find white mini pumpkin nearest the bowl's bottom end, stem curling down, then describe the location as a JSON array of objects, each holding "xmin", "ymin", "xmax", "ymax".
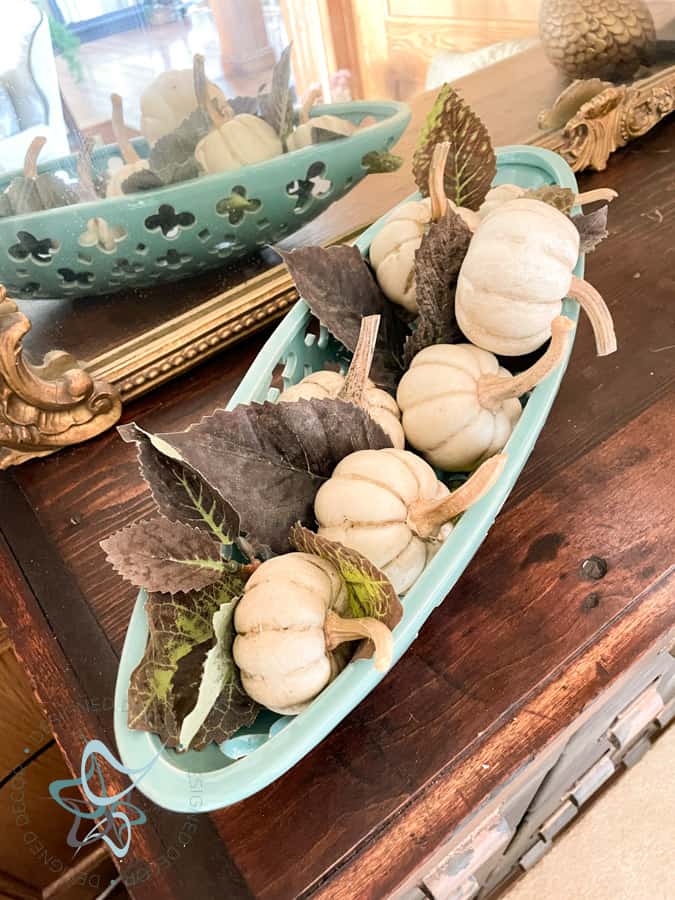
[{"xmin": 232, "ymin": 553, "xmax": 392, "ymax": 715}]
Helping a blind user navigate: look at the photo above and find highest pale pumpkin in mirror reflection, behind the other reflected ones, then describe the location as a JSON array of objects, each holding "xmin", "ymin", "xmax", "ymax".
[{"xmin": 141, "ymin": 69, "xmax": 227, "ymax": 144}]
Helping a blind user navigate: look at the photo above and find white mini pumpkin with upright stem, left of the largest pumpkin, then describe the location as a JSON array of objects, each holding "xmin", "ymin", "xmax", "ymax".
[{"xmin": 369, "ymin": 142, "xmax": 479, "ymax": 313}]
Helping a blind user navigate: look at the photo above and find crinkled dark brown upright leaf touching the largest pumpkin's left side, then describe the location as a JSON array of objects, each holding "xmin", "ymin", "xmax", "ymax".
[{"xmin": 405, "ymin": 205, "xmax": 472, "ymax": 366}]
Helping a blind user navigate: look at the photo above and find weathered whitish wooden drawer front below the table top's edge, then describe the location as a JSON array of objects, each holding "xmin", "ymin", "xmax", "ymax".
[{"xmin": 392, "ymin": 651, "xmax": 675, "ymax": 900}]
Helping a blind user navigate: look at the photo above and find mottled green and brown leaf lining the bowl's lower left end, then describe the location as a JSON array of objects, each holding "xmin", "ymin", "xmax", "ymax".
[{"xmin": 128, "ymin": 576, "xmax": 252, "ymax": 747}]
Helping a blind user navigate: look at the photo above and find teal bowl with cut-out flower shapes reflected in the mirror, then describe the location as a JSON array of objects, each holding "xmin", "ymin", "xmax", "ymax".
[{"xmin": 0, "ymin": 101, "xmax": 410, "ymax": 299}]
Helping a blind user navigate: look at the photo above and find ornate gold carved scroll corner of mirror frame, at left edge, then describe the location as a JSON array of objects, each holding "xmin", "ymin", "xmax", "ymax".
[{"xmin": 0, "ymin": 286, "xmax": 122, "ymax": 468}]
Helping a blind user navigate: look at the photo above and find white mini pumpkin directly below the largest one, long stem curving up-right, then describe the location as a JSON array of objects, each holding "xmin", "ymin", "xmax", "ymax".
[{"xmin": 396, "ymin": 316, "xmax": 574, "ymax": 471}]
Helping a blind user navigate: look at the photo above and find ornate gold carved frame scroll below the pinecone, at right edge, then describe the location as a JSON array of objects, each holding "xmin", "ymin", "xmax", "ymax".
[{"xmin": 532, "ymin": 66, "xmax": 675, "ymax": 172}]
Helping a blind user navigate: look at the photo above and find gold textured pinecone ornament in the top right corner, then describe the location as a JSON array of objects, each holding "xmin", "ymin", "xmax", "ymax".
[{"xmin": 539, "ymin": 0, "xmax": 656, "ymax": 78}]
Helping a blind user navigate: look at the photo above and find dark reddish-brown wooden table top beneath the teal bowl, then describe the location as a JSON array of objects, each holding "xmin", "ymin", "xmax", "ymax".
[{"xmin": 0, "ymin": 50, "xmax": 675, "ymax": 900}]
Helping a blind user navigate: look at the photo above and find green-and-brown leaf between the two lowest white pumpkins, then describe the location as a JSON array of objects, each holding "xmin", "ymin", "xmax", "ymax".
[{"xmin": 290, "ymin": 522, "xmax": 403, "ymax": 659}]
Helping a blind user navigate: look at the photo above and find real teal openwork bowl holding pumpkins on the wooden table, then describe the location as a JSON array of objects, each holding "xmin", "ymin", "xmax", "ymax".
[{"xmin": 115, "ymin": 147, "xmax": 584, "ymax": 812}]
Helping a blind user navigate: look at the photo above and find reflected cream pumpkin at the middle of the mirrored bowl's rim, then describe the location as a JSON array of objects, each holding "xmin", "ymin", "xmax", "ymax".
[{"xmin": 195, "ymin": 113, "xmax": 283, "ymax": 174}]
